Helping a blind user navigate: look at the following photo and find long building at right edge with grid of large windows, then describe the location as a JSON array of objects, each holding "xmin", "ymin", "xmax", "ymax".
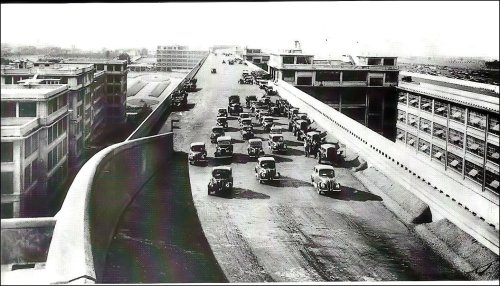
[{"xmin": 396, "ymin": 72, "xmax": 500, "ymax": 197}]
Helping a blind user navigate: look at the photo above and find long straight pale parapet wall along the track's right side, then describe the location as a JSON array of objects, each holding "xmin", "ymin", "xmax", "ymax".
[{"xmin": 277, "ymin": 80, "xmax": 499, "ymax": 254}]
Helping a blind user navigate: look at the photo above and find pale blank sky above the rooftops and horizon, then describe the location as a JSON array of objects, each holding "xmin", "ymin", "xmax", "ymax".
[{"xmin": 1, "ymin": 1, "xmax": 500, "ymax": 59}]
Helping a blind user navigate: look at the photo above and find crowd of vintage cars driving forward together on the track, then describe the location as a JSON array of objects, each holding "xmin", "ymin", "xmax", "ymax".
[{"xmin": 189, "ymin": 68, "xmax": 341, "ymax": 195}]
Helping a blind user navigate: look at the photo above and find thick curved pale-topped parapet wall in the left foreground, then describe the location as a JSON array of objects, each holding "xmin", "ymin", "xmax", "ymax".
[{"xmin": 46, "ymin": 133, "xmax": 173, "ymax": 283}]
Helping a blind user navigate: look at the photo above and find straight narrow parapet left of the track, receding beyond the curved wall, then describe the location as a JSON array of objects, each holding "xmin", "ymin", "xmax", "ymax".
[{"xmin": 127, "ymin": 53, "xmax": 209, "ymax": 140}]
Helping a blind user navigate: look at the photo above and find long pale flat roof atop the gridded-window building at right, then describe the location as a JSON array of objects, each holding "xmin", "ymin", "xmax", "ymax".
[{"xmin": 398, "ymin": 81, "xmax": 500, "ymax": 113}]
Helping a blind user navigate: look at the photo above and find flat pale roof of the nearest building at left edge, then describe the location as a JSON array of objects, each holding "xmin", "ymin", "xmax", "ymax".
[{"xmin": 0, "ymin": 84, "xmax": 68, "ymax": 101}]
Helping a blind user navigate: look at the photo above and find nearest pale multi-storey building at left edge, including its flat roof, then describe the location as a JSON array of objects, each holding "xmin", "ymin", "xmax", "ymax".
[{"xmin": 0, "ymin": 84, "xmax": 70, "ymax": 218}]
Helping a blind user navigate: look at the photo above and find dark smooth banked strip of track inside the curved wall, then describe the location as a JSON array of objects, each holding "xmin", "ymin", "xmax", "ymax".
[{"xmin": 100, "ymin": 152, "xmax": 227, "ymax": 284}]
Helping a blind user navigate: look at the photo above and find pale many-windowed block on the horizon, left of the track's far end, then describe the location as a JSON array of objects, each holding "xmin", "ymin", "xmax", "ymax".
[{"xmin": 156, "ymin": 45, "xmax": 208, "ymax": 71}]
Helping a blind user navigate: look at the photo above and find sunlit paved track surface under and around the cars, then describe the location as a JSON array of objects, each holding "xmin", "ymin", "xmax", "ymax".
[{"xmin": 161, "ymin": 55, "xmax": 464, "ymax": 282}]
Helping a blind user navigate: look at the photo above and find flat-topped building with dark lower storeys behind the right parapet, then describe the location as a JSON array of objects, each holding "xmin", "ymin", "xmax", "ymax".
[{"xmin": 268, "ymin": 48, "xmax": 399, "ymax": 139}]
